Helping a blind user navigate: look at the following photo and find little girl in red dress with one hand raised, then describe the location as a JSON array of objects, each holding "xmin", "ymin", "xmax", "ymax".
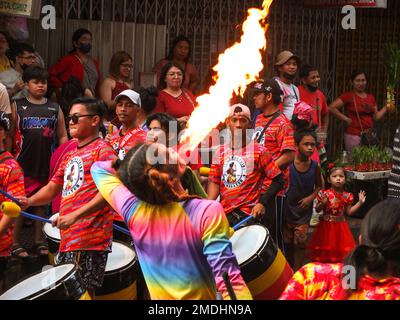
[{"xmin": 307, "ymin": 167, "xmax": 366, "ymax": 263}]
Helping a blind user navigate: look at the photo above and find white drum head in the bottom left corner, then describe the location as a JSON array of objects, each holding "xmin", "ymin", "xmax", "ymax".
[{"xmin": 0, "ymin": 264, "xmax": 75, "ymax": 300}]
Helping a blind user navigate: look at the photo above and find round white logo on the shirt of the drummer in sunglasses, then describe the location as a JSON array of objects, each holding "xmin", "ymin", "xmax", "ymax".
[{"xmin": 62, "ymin": 157, "xmax": 85, "ymax": 197}]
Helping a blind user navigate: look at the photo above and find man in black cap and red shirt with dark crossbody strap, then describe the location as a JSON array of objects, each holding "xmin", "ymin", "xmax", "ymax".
[{"xmin": 253, "ymin": 79, "xmax": 296, "ymax": 250}]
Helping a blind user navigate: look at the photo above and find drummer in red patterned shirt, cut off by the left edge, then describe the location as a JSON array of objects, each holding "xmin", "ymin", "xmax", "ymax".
[{"xmin": 0, "ymin": 112, "xmax": 25, "ymax": 292}]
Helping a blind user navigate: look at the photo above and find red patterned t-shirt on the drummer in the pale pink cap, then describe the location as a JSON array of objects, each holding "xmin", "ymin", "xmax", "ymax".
[{"xmin": 208, "ymin": 141, "xmax": 282, "ymax": 214}]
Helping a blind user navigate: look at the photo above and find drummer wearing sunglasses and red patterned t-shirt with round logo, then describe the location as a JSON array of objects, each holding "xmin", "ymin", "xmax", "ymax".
[{"xmin": 20, "ymin": 98, "xmax": 116, "ymax": 298}]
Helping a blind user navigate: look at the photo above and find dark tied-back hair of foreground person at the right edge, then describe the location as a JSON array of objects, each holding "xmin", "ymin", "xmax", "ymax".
[{"xmin": 344, "ymin": 199, "xmax": 400, "ymax": 292}]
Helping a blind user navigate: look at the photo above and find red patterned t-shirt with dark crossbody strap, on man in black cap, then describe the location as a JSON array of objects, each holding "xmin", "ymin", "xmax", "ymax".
[{"xmin": 253, "ymin": 114, "xmax": 296, "ymax": 196}]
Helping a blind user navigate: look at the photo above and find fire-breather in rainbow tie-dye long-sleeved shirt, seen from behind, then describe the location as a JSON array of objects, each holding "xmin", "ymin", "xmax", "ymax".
[{"xmin": 92, "ymin": 143, "xmax": 252, "ymax": 300}]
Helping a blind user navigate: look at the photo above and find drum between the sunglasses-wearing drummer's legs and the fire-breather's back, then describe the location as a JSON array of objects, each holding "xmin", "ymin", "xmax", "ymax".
[{"xmin": 96, "ymin": 241, "xmax": 139, "ymax": 300}]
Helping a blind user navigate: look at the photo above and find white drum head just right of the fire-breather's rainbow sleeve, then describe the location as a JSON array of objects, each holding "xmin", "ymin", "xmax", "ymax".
[{"xmin": 230, "ymin": 225, "xmax": 268, "ymax": 265}]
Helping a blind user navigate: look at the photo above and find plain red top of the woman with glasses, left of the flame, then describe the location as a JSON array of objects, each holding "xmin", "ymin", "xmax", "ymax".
[{"xmin": 154, "ymin": 89, "xmax": 195, "ymax": 119}]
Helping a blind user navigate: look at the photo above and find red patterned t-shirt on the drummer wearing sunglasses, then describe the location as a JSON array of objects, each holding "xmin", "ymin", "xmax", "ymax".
[{"xmin": 51, "ymin": 138, "xmax": 116, "ymax": 252}]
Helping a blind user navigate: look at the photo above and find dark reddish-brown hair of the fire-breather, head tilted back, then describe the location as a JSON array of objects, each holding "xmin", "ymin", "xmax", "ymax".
[{"xmin": 114, "ymin": 144, "xmax": 197, "ymax": 205}]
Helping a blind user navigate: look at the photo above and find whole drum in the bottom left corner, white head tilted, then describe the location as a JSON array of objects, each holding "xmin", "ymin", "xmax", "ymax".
[{"xmin": 0, "ymin": 264, "xmax": 90, "ymax": 300}]
